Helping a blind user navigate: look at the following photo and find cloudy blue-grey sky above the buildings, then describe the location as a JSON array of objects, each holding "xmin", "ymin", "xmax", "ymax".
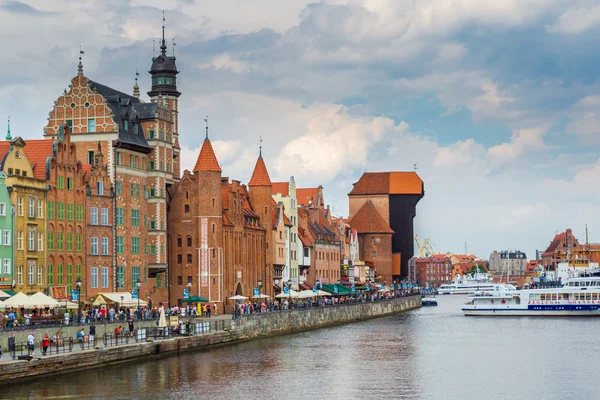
[{"xmin": 0, "ymin": 0, "xmax": 600, "ymax": 258}]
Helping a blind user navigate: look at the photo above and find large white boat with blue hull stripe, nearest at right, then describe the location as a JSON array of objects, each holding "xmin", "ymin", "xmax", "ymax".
[{"xmin": 462, "ymin": 276, "xmax": 600, "ymax": 317}]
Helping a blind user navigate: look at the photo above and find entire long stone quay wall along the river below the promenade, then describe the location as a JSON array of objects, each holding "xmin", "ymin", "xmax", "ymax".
[{"xmin": 0, "ymin": 296, "xmax": 421, "ymax": 385}]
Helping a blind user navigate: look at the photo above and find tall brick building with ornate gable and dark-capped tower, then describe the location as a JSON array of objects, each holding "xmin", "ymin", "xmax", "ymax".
[{"xmin": 44, "ymin": 27, "xmax": 181, "ymax": 301}]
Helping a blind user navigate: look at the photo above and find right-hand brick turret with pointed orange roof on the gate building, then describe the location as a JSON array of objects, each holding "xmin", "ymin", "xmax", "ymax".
[{"xmin": 248, "ymin": 144, "xmax": 275, "ymax": 295}]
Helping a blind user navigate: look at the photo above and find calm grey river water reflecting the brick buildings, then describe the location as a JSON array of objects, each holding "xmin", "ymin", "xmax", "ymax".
[{"xmin": 0, "ymin": 296, "xmax": 600, "ymax": 400}]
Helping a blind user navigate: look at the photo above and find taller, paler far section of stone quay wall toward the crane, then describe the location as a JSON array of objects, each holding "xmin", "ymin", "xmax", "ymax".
[{"xmin": 232, "ymin": 296, "xmax": 421, "ymax": 339}]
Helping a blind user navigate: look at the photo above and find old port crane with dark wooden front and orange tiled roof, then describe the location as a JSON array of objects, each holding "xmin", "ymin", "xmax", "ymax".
[{"xmin": 348, "ymin": 172, "xmax": 425, "ymax": 282}]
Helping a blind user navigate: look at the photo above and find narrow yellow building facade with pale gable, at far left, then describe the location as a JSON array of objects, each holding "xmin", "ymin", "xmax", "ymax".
[{"xmin": 0, "ymin": 137, "xmax": 47, "ymax": 294}]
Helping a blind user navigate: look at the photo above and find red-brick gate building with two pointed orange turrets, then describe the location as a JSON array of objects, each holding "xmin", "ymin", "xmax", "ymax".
[{"xmin": 168, "ymin": 133, "xmax": 274, "ymax": 312}]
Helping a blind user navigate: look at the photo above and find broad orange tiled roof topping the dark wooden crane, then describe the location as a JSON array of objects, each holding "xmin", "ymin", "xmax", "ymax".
[{"xmin": 348, "ymin": 172, "xmax": 423, "ymax": 196}]
